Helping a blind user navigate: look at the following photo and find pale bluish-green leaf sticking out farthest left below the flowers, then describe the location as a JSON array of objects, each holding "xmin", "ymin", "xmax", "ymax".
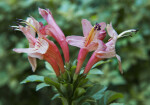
[{"xmin": 21, "ymin": 75, "xmax": 44, "ymax": 84}]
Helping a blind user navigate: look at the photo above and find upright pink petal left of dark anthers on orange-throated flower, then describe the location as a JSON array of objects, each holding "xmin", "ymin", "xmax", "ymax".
[{"xmin": 82, "ymin": 19, "xmax": 93, "ymax": 37}]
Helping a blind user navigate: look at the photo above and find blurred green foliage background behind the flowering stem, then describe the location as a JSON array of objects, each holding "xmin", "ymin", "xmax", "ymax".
[{"xmin": 0, "ymin": 0, "xmax": 150, "ymax": 105}]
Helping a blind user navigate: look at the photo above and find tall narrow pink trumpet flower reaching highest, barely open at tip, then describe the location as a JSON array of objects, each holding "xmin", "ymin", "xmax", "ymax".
[{"xmin": 39, "ymin": 8, "xmax": 69, "ymax": 63}]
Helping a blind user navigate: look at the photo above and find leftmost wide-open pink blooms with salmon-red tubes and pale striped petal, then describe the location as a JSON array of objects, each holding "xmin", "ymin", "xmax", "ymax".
[{"xmin": 13, "ymin": 18, "xmax": 65, "ymax": 76}]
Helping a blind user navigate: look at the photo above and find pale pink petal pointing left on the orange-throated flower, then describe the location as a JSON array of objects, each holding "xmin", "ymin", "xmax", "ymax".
[{"xmin": 66, "ymin": 36, "xmax": 85, "ymax": 48}]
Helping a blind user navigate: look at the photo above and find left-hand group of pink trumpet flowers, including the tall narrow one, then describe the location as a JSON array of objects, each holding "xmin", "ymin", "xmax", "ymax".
[{"xmin": 12, "ymin": 8, "xmax": 69, "ymax": 76}]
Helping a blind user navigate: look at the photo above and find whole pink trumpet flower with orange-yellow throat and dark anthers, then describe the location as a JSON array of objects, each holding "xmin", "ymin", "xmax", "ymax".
[{"xmin": 66, "ymin": 19, "xmax": 106, "ymax": 74}]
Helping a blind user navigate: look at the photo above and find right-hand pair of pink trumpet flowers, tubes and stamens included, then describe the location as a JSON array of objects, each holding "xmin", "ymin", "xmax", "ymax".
[{"xmin": 67, "ymin": 19, "xmax": 137, "ymax": 74}]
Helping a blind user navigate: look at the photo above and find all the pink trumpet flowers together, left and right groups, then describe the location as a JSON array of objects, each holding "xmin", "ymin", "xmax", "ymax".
[{"xmin": 12, "ymin": 8, "xmax": 136, "ymax": 76}]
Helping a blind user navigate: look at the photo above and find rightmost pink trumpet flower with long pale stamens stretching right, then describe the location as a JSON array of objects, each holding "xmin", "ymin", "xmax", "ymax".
[{"xmin": 84, "ymin": 24, "xmax": 137, "ymax": 74}]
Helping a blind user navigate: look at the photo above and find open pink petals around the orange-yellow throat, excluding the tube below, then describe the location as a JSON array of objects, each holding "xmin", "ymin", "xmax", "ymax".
[{"xmin": 66, "ymin": 19, "xmax": 106, "ymax": 51}]
